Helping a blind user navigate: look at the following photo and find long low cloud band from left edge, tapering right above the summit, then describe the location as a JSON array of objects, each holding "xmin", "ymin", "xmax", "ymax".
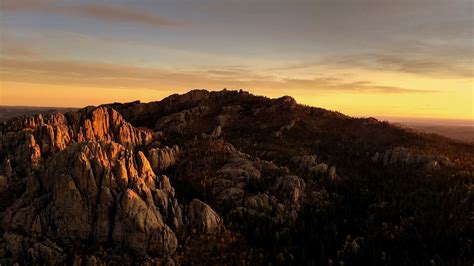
[{"xmin": 0, "ymin": 58, "xmax": 434, "ymax": 94}]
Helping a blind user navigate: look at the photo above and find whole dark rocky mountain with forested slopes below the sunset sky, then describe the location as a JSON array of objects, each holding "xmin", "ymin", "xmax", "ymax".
[{"xmin": 0, "ymin": 90, "xmax": 474, "ymax": 265}]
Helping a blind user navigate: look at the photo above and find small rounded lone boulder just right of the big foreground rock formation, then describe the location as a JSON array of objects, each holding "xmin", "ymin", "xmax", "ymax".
[{"xmin": 186, "ymin": 199, "xmax": 224, "ymax": 234}]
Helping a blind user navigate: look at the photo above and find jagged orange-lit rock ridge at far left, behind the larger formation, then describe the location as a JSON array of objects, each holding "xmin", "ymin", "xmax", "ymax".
[{"xmin": 0, "ymin": 107, "xmax": 152, "ymax": 178}]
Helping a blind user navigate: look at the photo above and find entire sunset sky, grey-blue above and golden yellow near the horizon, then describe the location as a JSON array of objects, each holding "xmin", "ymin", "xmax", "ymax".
[{"xmin": 0, "ymin": 0, "xmax": 474, "ymax": 120}]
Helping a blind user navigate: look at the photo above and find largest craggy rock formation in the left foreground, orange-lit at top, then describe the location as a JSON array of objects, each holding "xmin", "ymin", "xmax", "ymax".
[{"xmin": 5, "ymin": 142, "xmax": 182, "ymax": 262}]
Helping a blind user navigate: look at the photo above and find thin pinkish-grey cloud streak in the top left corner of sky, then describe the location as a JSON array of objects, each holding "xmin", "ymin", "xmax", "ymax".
[{"xmin": 1, "ymin": 0, "xmax": 181, "ymax": 27}]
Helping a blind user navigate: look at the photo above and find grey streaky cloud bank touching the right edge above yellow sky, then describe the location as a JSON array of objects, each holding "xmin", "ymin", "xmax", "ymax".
[{"xmin": 274, "ymin": 40, "xmax": 474, "ymax": 79}]
